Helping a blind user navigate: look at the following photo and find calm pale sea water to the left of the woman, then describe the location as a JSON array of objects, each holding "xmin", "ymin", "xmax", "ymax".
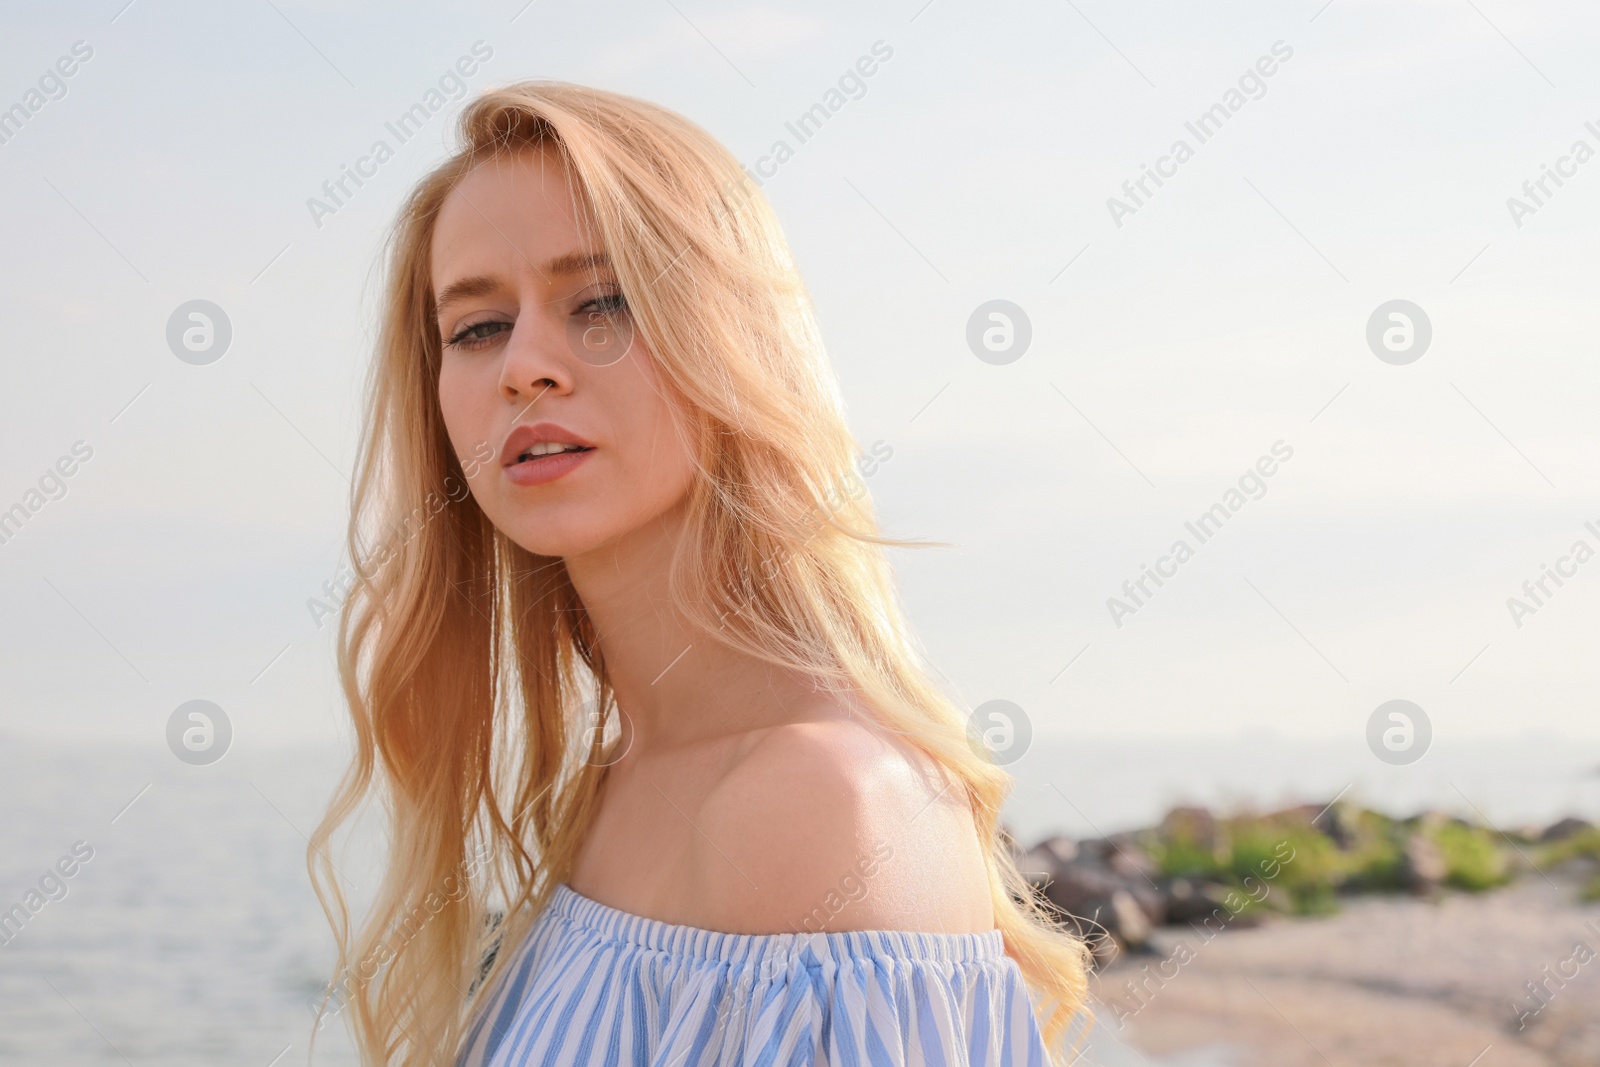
[{"xmin": 0, "ymin": 742, "xmax": 355, "ymax": 1067}]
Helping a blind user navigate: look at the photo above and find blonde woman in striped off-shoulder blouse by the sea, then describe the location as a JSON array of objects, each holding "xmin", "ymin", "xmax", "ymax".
[{"xmin": 309, "ymin": 82, "xmax": 1086, "ymax": 1067}]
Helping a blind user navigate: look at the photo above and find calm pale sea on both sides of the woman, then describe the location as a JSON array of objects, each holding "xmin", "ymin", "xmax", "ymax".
[{"xmin": 0, "ymin": 737, "xmax": 1600, "ymax": 1067}]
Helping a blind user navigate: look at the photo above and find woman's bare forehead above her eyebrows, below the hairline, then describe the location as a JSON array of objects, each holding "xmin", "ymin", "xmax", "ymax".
[{"xmin": 430, "ymin": 149, "xmax": 595, "ymax": 293}]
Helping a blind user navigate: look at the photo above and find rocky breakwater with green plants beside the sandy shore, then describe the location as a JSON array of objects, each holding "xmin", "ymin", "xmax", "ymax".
[{"xmin": 1013, "ymin": 803, "xmax": 1600, "ymax": 966}]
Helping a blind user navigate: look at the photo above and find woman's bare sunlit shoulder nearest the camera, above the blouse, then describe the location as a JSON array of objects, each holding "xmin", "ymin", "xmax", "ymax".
[{"xmin": 694, "ymin": 715, "xmax": 994, "ymax": 933}]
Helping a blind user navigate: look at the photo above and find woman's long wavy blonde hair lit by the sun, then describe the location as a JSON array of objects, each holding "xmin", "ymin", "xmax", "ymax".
[{"xmin": 307, "ymin": 82, "xmax": 1088, "ymax": 1067}]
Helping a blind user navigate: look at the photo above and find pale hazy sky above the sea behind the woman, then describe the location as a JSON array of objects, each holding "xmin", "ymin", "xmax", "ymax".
[{"xmin": 0, "ymin": 0, "xmax": 1600, "ymax": 745}]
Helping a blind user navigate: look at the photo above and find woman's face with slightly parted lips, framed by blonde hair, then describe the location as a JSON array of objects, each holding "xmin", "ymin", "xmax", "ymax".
[{"xmin": 432, "ymin": 150, "xmax": 693, "ymax": 557}]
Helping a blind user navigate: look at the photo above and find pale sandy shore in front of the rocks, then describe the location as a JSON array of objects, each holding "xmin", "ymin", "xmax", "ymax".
[{"xmin": 1091, "ymin": 875, "xmax": 1600, "ymax": 1067}]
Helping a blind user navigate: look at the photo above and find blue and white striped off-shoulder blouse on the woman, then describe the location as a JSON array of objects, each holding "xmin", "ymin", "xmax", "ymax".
[{"xmin": 458, "ymin": 885, "xmax": 1046, "ymax": 1067}]
